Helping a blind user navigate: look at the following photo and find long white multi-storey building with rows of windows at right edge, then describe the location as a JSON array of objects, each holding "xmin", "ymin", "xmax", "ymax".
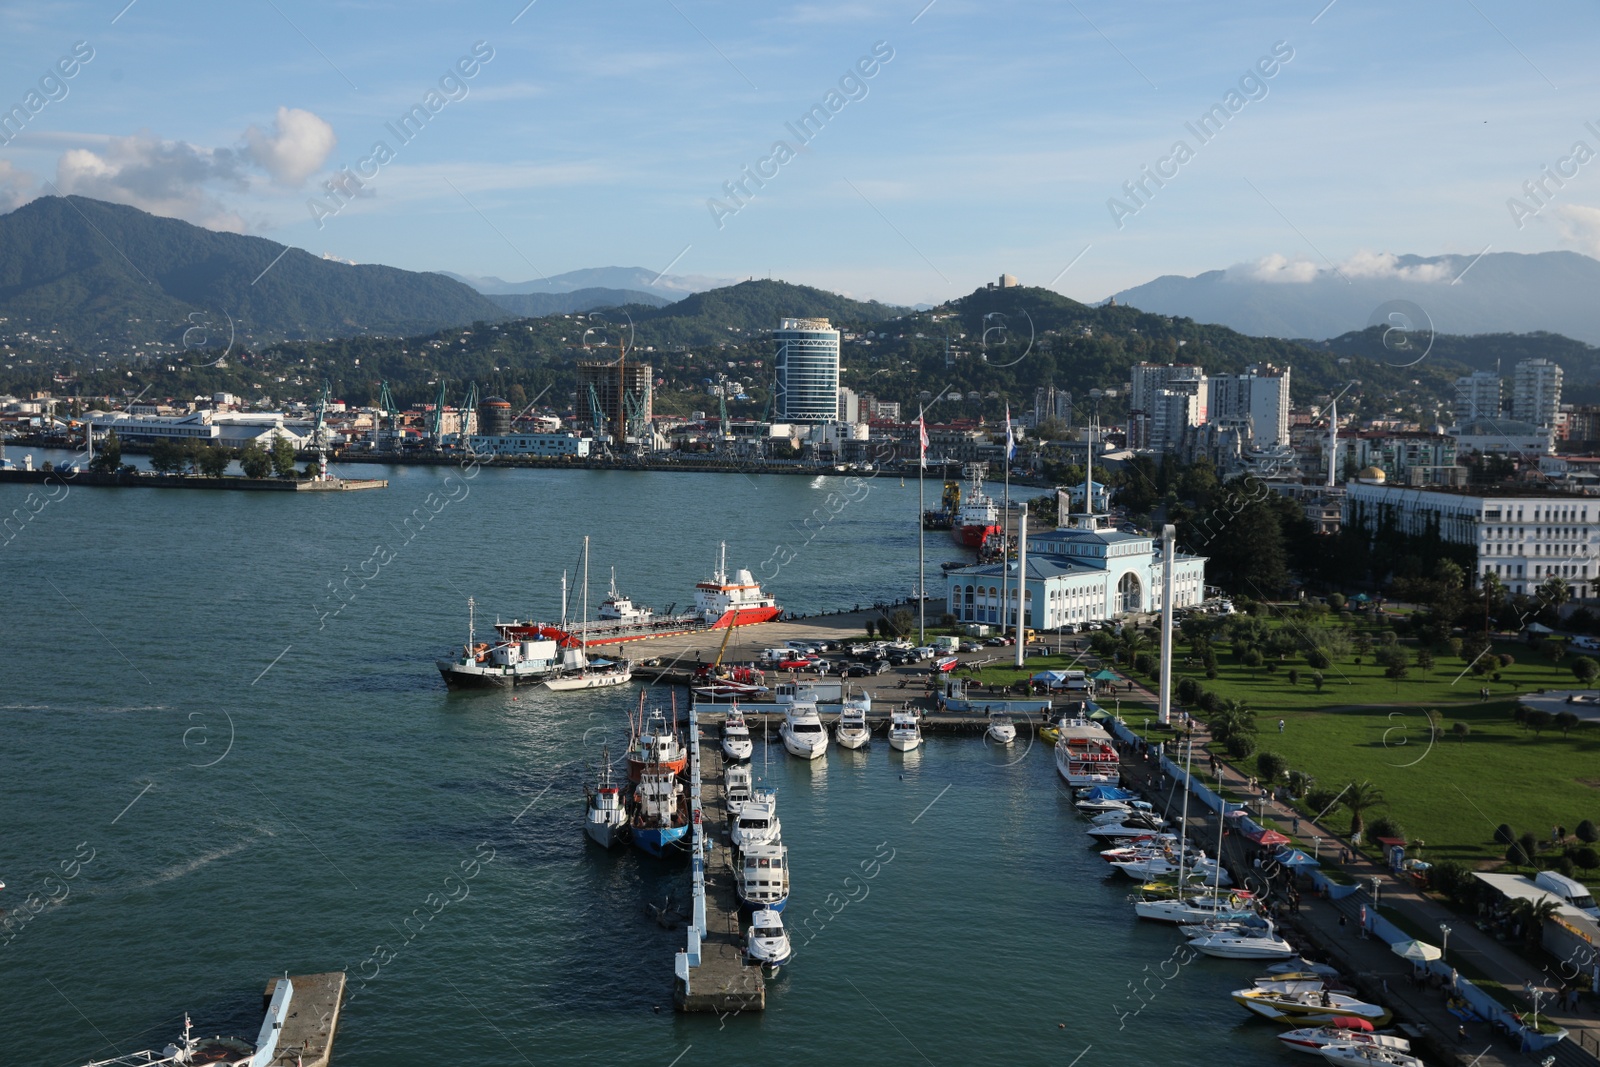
[{"xmin": 1344, "ymin": 482, "xmax": 1600, "ymax": 597}]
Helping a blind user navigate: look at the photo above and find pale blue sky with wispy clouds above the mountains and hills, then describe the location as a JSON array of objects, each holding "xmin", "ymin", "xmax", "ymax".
[{"xmin": 0, "ymin": 0, "xmax": 1600, "ymax": 304}]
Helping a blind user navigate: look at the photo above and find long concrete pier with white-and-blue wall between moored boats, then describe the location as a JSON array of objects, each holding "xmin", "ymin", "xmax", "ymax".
[{"xmin": 674, "ymin": 717, "xmax": 766, "ymax": 1014}]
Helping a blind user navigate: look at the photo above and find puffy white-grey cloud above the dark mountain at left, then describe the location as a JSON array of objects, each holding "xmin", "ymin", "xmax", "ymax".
[{"xmin": 56, "ymin": 133, "xmax": 250, "ymax": 234}]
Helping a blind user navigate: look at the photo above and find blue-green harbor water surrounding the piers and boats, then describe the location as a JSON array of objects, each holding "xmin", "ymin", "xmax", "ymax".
[{"xmin": 0, "ymin": 454, "xmax": 1286, "ymax": 1067}]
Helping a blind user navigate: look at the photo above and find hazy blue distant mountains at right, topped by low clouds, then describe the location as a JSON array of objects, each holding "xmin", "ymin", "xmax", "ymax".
[{"xmin": 1115, "ymin": 251, "xmax": 1600, "ymax": 344}]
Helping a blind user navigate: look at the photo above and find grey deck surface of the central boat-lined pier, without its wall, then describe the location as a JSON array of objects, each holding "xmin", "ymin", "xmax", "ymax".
[{"xmin": 677, "ymin": 731, "xmax": 766, "ymax": 1014}]
